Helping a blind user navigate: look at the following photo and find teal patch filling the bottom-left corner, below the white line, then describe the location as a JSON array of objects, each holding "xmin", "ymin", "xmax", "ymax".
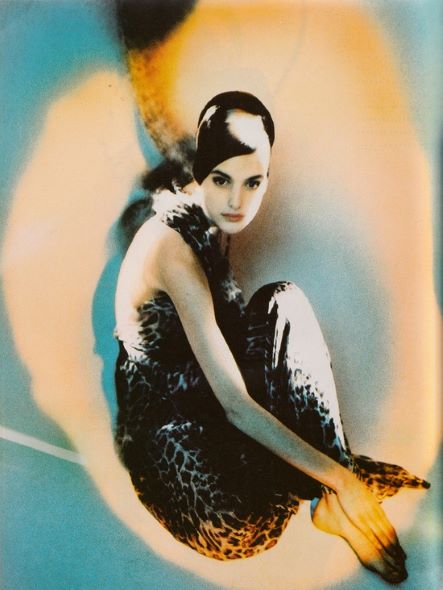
[{"xmin": 0, "ymin": 441, "xmax": 219, "ymax": 590}]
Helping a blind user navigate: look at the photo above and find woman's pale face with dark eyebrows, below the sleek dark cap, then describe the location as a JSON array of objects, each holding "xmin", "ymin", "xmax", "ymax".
[{"xmin": 201, "ymin": 133, "xmax": 271, "ymax": 234}]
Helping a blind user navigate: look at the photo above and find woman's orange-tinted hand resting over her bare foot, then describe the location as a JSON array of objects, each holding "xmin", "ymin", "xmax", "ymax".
[{"xmin": 337, "ymin": 472, "xmax": 406, "ymax": 562}]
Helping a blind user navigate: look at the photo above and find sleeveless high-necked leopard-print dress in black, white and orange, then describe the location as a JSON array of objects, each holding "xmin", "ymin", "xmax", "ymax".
[{"xmin": 115, "ymin": 199, "xmax": 428, "ymax": 560}]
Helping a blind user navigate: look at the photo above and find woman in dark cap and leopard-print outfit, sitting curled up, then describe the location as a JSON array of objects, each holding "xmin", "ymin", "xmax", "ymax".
[{"xmin": 116, "ymin": 92, "xmax": 429, "ymax": 582}]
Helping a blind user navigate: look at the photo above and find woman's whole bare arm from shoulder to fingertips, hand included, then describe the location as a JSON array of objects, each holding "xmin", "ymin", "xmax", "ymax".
[{"xmin": 158, "ymin": 230, "xmax": 402, "ymax": 547}]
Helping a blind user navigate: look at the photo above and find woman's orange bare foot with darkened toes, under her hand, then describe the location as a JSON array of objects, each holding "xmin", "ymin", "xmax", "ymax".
[{"xmin": 312, "ymin": 494, "xmax": 408, "ymax": 584}]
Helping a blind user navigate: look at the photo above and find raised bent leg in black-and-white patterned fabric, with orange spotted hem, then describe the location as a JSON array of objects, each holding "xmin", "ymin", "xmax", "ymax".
[{"xmin": 245, "ymin": 282, "xmax": 429, "ymax": 501}]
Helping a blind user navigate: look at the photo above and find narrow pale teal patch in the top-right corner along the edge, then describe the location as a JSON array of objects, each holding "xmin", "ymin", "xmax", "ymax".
[{"xmin": 364, "ymin": 0, "xmax": 443, "ymax": 309}]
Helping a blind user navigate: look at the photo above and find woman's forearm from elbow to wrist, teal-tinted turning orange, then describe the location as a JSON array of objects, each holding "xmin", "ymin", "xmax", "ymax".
[{"xmin": 226, "ymin": 398, "xmax": 354, "ymax": 491}]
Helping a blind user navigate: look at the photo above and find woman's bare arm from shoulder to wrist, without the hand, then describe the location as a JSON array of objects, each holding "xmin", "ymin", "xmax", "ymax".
[{"xmin": 159, "ymin": 229, "xmax": 349, "ymax": 490}]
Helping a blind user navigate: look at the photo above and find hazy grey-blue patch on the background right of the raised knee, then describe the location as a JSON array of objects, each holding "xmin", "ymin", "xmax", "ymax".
[{"xmin": 280, "ymin": 194, "xmax": 393, "ymax": 432}]
